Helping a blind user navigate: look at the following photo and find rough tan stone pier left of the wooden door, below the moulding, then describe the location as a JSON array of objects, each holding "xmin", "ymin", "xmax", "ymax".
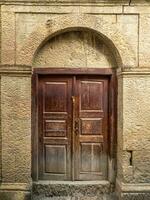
[{"xmin": 1, "ymin": 76, "xmax": 31, "ymax": 183}]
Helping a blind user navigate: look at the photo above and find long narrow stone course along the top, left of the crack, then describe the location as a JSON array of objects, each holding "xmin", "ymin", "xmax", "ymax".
[{"xmin": 2, "ymin": 4, "xmax": 122, "ymax": 15}]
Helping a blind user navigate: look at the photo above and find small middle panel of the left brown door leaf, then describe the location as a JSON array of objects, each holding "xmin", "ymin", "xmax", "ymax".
[{"xmin": 45, "ymin": 119, "xmax": 67, "ymax": 137}]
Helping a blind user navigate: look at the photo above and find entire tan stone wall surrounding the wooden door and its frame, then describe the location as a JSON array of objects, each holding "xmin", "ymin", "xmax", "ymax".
[{"xmin": 0, "ymin": 0, "xmax": 150, "ymax": 200}]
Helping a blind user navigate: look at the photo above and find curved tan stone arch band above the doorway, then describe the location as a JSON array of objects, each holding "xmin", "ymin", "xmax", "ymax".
[{"xmin": 17, "ymin": 14, "xmax": 136, "ymax": 67}]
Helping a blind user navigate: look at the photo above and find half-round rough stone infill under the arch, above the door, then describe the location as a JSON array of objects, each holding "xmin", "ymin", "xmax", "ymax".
[{"xmin": 34, "ymin": 31, "xmax": 116, "ymax": 68}]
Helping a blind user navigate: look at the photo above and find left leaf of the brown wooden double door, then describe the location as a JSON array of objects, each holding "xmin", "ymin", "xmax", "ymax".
[{"xmin": 38, "ymin": 76, "xmax": 72, "ymax": 180}]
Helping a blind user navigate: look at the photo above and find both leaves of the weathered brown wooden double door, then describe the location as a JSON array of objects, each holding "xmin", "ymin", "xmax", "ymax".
[{"xmin": 38, "ymin": 75, "xmax": 108, "ymax": 180}]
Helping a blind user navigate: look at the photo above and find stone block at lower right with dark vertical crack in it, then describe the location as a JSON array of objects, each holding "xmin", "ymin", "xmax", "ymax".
[{"xmin": 117, "ymin": 150, "xmax": 150, "ymax": 183}]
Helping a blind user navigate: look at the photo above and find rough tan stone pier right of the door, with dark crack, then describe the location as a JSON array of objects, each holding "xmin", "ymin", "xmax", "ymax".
[{"xmin": 117, "ymin": 75, "xmax": 150, "ymax": 183}]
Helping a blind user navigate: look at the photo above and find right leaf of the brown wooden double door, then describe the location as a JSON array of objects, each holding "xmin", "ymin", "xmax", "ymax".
[{"xmin": 75, "ymin": 76, "xmax": 108, "ymax": 180}]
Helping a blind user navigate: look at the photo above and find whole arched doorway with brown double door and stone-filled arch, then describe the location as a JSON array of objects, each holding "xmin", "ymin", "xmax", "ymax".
[{"xmin": 33, "ymin": 31, "xmax": 116, "ymax": 183}]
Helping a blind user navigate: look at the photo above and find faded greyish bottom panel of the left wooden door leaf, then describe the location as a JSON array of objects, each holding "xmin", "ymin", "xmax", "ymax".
[{"xmin": 45, "ymin": 145, "xmax": 67, "ymax": 174}]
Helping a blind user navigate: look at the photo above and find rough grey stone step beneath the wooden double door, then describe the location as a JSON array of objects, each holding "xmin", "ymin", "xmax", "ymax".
[{"xmin": 32, "ymin": 181, "xmax": 118, "ymax": 200}]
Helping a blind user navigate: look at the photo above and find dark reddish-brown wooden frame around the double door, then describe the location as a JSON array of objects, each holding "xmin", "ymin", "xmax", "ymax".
[{"xmin": 31, "ymin": 68, "xmax": 117, "ymax": 182}]
